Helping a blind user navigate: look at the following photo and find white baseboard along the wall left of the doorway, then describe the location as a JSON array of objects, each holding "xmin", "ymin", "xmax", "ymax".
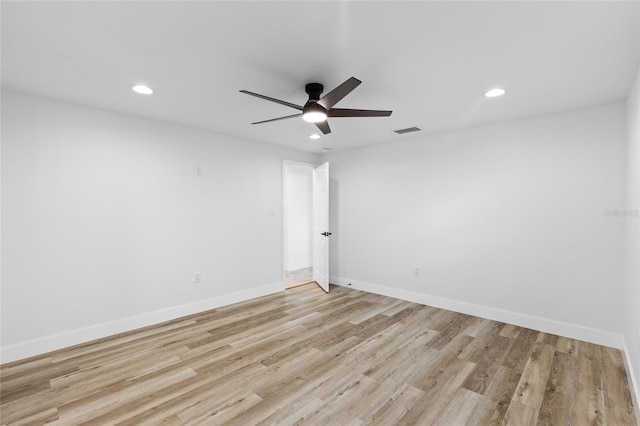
[{"xmin": 0, "ymin": 283, "xmax": 284, "ymax": 364}]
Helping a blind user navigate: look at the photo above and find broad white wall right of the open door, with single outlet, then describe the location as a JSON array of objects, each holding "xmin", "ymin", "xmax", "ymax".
[{"xmin": 323, "ymin": 104, "xmax": 626, "ymax": 347}]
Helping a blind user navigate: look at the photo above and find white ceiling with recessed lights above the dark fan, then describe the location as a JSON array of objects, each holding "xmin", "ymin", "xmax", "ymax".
[{"xmin": 1, "ymin": 1, "xmax": 640, "ymax": 152}]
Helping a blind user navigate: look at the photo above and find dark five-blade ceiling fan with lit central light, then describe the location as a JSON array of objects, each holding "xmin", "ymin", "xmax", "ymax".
[{"xmin": 240, "ymin": 77, "xmax": 392, "ymax": 135}]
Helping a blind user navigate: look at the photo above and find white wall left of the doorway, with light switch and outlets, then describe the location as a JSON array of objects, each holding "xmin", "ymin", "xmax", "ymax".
[{"xmin": 1, "ymin": 92, "xmax": 317, "ymax": 362}]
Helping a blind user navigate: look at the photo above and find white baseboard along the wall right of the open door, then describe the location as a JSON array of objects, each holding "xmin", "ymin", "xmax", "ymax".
[{"xmin": 329, "ymin": 276, "xmax": 622, "ymax": 349}]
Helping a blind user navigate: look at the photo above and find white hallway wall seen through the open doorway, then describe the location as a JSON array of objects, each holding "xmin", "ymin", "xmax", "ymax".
[{"xmin": 283, "ymin": 163, "xmax": 313, "ymax": 271}]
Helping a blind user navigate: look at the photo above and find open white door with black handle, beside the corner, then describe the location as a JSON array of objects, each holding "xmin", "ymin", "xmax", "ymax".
[{"xmin": 313, "ymin": 163, "xmax": 331, "ymax": 292}]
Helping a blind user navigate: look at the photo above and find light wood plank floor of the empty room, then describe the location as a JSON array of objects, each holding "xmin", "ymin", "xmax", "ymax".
[{"xmin": 0, "ymin": 284, "xmax": 636, "ymax": 426}]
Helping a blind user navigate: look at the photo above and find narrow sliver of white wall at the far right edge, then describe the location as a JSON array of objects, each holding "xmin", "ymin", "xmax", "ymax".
[{"xmin": 621, "ymin": 66, "xmax": 640, "ymax": 416}]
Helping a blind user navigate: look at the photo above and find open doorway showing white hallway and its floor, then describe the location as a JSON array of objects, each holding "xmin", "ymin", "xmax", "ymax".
[{"xmin": 282, "ymin": 160, "xmax": 315, "ymax": 288}]
